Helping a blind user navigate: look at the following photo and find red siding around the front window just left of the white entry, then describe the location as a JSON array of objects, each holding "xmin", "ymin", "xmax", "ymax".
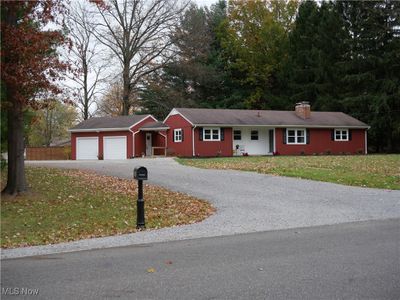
[{"xmin": 194, "ymin": 128, "xmax": 233, "ymax": 156}]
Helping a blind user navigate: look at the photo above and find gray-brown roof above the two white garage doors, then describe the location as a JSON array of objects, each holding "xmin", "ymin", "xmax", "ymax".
[{"xmin": 70, "ymin": 115, "xmax": 150, "ymax": 131}]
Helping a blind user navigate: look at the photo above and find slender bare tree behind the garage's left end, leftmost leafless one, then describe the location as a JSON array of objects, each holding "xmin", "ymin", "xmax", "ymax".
[{"xmin": 67, "ymin": 1, "xmax": 107, "ymax": 120}]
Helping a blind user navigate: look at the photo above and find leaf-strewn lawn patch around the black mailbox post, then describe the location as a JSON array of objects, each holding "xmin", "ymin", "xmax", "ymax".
[{"xmin": 1, "ymin": 168, "xmax": 215, "ymax": 248}]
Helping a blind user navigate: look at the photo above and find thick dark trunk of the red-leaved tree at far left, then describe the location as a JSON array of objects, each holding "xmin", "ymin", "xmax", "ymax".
[{"xmin": 2, "ymin": 96, "xmax": 27, "ymax": 195}]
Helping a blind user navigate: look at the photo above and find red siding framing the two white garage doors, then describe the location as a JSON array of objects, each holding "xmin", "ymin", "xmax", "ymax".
[{"xmin": 71, "ymin": 131, "xmax": 132, "ymax": 160}]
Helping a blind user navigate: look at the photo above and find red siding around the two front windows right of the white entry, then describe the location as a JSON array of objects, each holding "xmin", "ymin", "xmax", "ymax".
[{"xmin": 275, "ymin": 128, "xmax": 365, "ymax": 155}]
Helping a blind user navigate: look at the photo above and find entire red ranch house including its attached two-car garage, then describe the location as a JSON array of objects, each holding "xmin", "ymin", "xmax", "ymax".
[{"xmin": 70, "ymin": 102, "xmax": 368, "ymax": 159}]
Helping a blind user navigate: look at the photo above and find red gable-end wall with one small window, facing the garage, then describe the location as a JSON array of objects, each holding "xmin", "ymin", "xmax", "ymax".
[{"xmin": 164, "ymin": 115, "xmax": 193, "ymax": 157}]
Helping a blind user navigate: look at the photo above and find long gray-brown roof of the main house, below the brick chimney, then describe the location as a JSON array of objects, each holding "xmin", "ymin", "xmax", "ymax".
[{"xmin": 175, "ymin": 108, "xmax": 368, "ymax": 128}]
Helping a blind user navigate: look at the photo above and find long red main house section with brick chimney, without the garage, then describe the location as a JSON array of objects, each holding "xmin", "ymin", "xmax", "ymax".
[{"xmin": 164, "ymin": 102, "xmax": 368, "ymax": 157}]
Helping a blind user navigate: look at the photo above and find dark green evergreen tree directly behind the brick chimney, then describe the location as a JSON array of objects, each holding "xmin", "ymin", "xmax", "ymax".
[{"xmin": 286, "ymin": 1, "xmax": 346, "ymax": 110}]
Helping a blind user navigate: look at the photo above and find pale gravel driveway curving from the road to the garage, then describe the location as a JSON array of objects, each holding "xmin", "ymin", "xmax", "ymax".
[{"xmin": 2, "ymin": 158, "xmax": 400, "ymax": 257}]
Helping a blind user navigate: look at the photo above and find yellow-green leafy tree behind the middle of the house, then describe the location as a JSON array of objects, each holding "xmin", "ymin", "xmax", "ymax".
[{"xmin": 221, "ymin": 0, "xmax": 298, "ymax": 108}]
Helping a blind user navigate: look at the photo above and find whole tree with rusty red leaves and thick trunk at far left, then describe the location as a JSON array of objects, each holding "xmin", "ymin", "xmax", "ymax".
[{"xmin": 1, "ymin": 0, "xmax": 66, "ymax": 194}]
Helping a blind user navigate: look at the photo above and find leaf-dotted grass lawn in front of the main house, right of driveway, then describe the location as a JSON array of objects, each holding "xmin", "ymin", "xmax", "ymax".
[{"xmin": 177, "ymin": 155, "xmax": 400, "ymax": 190}]
